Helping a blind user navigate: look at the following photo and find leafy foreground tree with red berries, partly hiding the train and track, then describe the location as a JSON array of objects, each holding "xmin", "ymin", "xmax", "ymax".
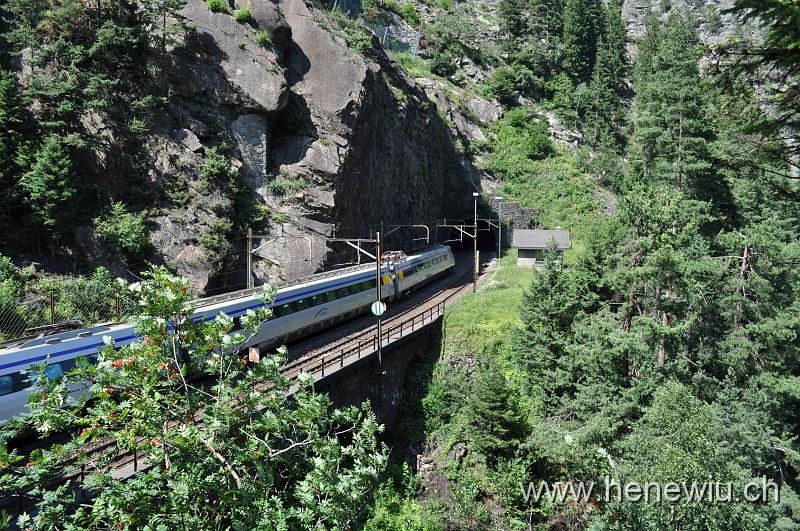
[{"xmin": 0, "ymin": 268, "xmax": 386, "ymax": 529}]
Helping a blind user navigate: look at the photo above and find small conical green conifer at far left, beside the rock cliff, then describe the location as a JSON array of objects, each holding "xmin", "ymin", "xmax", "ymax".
[{"xmin": 20, "ymin": 135, "xmax": 77, "ymax": 236}]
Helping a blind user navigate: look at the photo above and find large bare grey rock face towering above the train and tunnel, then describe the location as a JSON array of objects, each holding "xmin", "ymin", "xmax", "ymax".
[{"xmin": 115, "ymin": 0, "xmax": 480, "ymax": 291}]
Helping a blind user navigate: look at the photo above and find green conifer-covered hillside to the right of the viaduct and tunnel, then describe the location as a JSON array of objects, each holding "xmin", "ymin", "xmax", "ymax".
[{"xmin": 366, "ymin": 0, "xmax": 800, "ymax": 529}]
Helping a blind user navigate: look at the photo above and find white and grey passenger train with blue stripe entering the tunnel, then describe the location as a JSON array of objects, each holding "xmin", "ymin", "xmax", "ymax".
[{"xmin": 0, "ymin": 245, "xmax": 455, "ymax": 422}]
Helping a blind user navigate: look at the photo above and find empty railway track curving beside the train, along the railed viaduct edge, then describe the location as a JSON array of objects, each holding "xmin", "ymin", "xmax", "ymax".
[{"xmin": 0, "ymin": 260, "xmax": 488, "ymax": 514}]
